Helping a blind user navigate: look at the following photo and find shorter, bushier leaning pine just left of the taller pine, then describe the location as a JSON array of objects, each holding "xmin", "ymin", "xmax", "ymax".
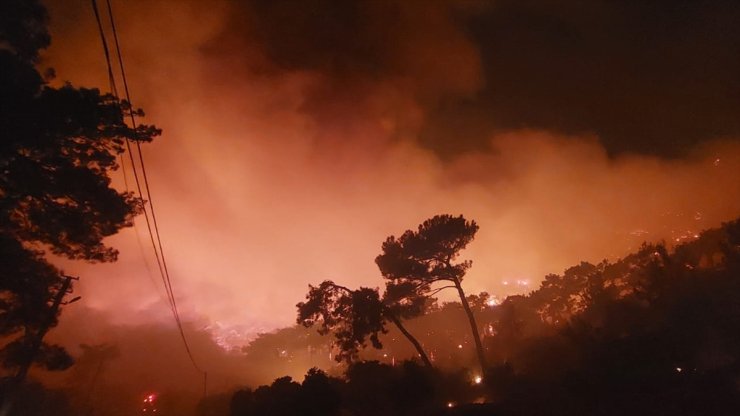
[{"xmin": 296, "ymin": 280, "xmax": 432, "ymax": 367}]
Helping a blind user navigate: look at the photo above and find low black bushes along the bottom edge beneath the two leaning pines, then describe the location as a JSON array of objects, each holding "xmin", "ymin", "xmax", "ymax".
[{"xmin": 230, "ymin": 361, "xmax": 474, "ymax": 416}]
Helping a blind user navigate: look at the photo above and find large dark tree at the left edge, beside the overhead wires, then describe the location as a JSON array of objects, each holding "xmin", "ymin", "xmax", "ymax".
[{"xmin": 0, "ymin": 0, "xmax": 160, "ymax": 386}]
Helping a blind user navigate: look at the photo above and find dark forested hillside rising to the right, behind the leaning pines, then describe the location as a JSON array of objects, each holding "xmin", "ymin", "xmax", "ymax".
[{"xmin": 7, "ymin": 213, "xmax": 740, "ymax": 416}]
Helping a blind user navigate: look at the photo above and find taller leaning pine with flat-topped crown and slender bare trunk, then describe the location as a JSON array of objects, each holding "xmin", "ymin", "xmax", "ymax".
[{"xmin": 375, "ymin": 215, "xmax": 486, "ymax": 373}]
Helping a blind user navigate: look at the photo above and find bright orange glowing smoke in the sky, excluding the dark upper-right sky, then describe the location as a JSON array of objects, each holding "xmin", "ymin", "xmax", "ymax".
[{"xmin": 44, "ymin": 1, "xmax": 740, "ymax": 348}]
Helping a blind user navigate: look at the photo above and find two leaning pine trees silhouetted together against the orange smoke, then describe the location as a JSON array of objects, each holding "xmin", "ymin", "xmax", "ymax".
[{"xmin": 296, "ymin": 215, "xmax": 485, "ymax": 368}]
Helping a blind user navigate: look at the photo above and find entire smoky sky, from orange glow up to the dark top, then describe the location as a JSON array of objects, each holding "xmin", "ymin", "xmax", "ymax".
[{"xmin": 44, "ymin": 0, "xmax": 740, "ymax": 344}]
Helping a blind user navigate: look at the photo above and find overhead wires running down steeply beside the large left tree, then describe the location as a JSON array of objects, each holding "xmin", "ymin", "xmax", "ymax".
[{"xmin": 91, "ymin": 0, "xmax": 207, "ymax": 376}]
